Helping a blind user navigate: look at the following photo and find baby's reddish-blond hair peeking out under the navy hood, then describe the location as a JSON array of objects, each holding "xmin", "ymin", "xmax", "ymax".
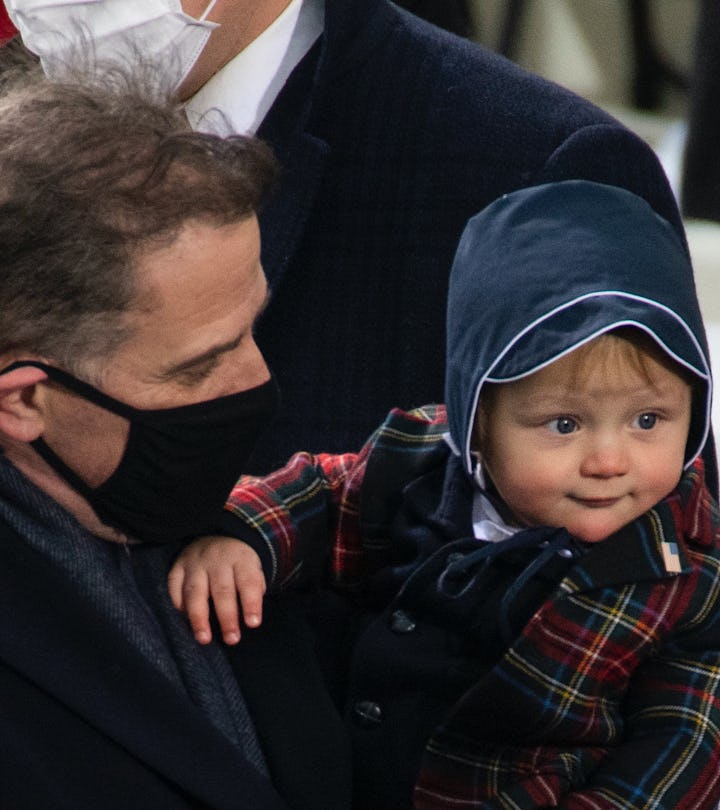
[{"xmin": 473, "ymin": 326, "xmax": 698, "ymax": 450}]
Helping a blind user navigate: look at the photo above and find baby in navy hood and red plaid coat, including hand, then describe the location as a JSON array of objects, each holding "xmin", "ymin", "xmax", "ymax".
[{"xmin": 169, "ymin": 181, "xmax": 720, "ymax": 810}]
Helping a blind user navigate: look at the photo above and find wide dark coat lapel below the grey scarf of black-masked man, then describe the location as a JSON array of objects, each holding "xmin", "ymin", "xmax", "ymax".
[{"xmin": 0, "ymin": 535, "xmax": 285, "ymax": 810}]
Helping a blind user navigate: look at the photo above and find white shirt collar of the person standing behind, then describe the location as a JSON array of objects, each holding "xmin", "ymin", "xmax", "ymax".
[{"xmin": 185, "ymin": 0, "xmax": 325, "ymax": 135}]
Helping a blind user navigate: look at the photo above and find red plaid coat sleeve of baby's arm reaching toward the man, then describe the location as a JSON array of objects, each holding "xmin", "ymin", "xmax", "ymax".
[{"xmin": 220, "ymin": 405, "xmax": 447, "ymax": 591}]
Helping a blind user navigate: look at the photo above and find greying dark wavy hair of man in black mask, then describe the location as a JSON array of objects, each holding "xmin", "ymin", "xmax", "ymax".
[{"xmin": 0, "ymin": 68, "xmax": 276, "ymax": 370}]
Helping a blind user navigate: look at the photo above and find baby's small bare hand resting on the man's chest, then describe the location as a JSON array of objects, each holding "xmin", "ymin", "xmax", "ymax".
[{"xmin": 168, "ymin": 537, "xmax": 265, "ymax": 644}]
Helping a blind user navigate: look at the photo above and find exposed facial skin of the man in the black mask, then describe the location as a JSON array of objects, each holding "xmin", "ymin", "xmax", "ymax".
[{"xmin": 37, "ymin": 216, "xmax": 270, "ymax": 486}]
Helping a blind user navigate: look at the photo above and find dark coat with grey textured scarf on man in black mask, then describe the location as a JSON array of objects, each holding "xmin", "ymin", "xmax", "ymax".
[{"xmin": 0, "ymin": 458, "xmax": 350, "ymax": 810}]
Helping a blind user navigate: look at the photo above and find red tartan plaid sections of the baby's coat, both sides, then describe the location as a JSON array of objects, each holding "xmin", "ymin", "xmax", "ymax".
[{"xmin": 228, "ymin": 406, "xmax": 720, "ymax": 810}]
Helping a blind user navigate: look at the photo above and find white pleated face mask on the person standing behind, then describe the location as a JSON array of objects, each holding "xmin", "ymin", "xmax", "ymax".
[{"xmin": 5, "ymin": 0, "xmax": 218, "ymax": 88}]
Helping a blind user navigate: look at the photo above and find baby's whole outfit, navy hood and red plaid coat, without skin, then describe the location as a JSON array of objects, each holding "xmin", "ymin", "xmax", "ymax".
[{"xmin": 229, "ymin": 181, "xmax": 720, "ymax": 810}]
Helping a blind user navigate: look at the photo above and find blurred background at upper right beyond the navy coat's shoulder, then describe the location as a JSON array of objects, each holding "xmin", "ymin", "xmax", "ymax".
[{"xmin": 396, "ymin": 0, "xmax": 720, "ymax": 426}]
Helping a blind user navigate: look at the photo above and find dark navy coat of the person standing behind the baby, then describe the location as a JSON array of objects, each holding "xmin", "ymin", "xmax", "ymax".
[{"xmin": 251, "ymin": 0, "xmax": 688, "ymax": 477}]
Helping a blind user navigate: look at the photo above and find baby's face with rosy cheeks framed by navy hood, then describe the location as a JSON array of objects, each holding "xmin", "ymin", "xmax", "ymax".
[{"xmin": 482, "ymin": 356, "xmax": 691, "ymax": 543}]
